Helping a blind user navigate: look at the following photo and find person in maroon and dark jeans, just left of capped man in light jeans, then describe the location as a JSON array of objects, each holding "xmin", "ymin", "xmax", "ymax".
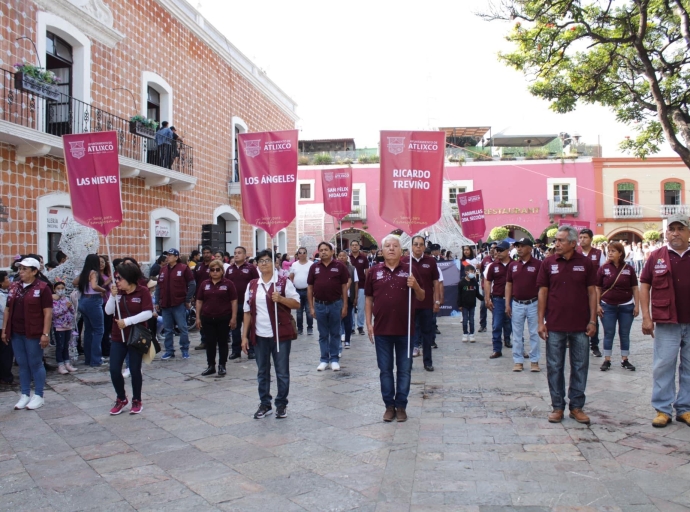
[{"xmin": 484, "ymin": 241, "xmax": 513, "ymax": 359}]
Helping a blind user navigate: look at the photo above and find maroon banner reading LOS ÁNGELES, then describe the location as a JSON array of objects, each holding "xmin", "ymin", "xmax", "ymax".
[{"xmin": 238, "ymin": 130, "xmax": 297, "ymax": 238}]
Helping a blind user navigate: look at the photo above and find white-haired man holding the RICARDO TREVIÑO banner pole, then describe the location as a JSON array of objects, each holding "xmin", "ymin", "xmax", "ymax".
[{"xmin": 365, "ymin": 235, "xmax": 425, "ymax": 422}]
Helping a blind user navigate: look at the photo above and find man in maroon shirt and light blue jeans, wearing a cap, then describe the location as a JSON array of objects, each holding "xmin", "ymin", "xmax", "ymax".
[{"xmin": 506, "ymin": 238, "xmax": 541, "ymax": 372}]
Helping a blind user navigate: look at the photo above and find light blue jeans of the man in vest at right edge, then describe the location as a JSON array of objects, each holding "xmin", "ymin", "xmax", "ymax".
[{"xmin": 652, "ymin": 323, "xmax": 690, "ymax": 415}]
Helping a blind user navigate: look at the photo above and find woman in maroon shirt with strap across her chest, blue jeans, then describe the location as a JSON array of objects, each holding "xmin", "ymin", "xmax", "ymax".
[{"xmin": 597, "ymin": 242, "xmax": 639, "ymax": 372}]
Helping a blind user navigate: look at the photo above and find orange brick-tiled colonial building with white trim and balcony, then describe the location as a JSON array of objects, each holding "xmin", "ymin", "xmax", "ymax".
[{"xmin": 0, "ymin": 0, "xmax": 297, "ymax": 267}]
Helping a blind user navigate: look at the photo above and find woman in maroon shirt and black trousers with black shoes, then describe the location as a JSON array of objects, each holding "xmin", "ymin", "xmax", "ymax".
[{"xmin": 196, "ymin": 260, "xmax": 237, "ymax": 377}]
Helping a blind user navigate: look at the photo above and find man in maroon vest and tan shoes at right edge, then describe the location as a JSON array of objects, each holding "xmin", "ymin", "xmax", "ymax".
[{"xmin": 640, "ymin": 214, "xmax": 690, "ymax": 427}]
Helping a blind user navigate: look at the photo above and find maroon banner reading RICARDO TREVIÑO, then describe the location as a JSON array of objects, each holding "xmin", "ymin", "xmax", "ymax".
[{"xmin": 379, "ymin": 131, "xmax": 446, "ymax": 235}]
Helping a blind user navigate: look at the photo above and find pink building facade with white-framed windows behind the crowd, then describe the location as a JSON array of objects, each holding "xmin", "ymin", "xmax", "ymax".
[{"xmin": 297, "ymin": 158, "xmax": 596, "ymax": 247}]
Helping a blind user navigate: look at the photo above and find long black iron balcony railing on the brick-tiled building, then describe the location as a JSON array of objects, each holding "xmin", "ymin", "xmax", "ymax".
[{"xmin": 0, "ymin": 69, "xmax": 194, "ymax": 176}]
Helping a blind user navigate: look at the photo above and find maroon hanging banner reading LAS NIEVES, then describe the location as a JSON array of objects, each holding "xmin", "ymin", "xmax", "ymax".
[{"xmin": 62, "ymin": 132, "xmax": 122, "ymax": 236}]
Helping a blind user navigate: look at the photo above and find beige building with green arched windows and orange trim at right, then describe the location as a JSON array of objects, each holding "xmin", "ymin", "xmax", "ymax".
[{"xmin": 593, "ymin": 158, "xmax": 690, "ymax": 242}]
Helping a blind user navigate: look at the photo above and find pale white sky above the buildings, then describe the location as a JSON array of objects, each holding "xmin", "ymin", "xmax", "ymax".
[{"xmin": 196, "ymin": 0, "xmax": 673, "ymax": 156}]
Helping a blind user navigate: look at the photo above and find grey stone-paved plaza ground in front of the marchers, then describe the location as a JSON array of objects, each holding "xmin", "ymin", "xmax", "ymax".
[{"xmin": 0, "ymin": 318, "xmax": 690, "ymax": 512}]
